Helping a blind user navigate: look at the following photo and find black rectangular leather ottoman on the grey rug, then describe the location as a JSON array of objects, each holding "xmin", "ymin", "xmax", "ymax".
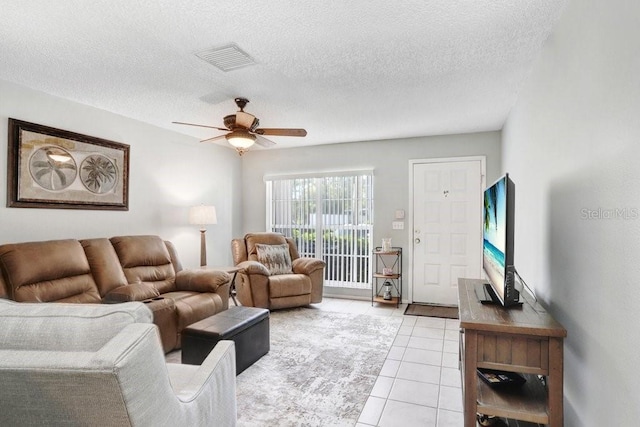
[{"xmin": 182, "ymin": 307, "xmax": 270, "ymax": 375}]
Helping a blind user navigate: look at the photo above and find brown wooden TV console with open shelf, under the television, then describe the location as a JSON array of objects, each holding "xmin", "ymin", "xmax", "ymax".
[{"xmin": 458, "ymin": 279, "xmax": 567, "ymax": 427}]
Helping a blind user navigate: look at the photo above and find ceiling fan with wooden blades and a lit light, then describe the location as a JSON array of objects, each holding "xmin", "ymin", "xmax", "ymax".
[{"xmin": 172, "ymin": 98, "xmax": 307, "ymax": 156}]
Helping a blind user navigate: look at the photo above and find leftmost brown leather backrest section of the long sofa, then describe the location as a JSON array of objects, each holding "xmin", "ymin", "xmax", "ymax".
[{"xmin": 0, "ymin": 239, "xmax": 100, "ymax": 303}]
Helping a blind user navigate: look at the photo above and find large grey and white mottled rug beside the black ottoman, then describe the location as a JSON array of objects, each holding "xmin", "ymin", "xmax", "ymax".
[{"xmin": 237, "ymin": 307, "xmax": 402, "ymax": 427}]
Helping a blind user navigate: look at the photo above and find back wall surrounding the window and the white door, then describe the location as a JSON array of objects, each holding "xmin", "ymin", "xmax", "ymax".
[{"xmin": 242, "ymin": 132, "xmax": 501, "ymax": 298}]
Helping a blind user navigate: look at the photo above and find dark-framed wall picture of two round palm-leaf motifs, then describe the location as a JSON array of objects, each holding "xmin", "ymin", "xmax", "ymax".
[{"xmin": 7, "ymin": 118, "xmax": 129, "ymax": 211}]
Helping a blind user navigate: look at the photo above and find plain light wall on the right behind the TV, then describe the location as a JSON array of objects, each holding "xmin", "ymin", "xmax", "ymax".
[{"xmin": 503, "ymin": 0, "xmax": 640, "ymax": 427}]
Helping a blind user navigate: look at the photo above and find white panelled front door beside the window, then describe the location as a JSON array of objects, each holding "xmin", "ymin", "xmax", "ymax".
[{"xmin": 411, "ymin": 159, "xmax": 484, "ymax": 305}]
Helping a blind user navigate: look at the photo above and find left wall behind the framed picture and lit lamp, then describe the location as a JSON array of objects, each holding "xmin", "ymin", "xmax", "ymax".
[{"xmin": 0, "ymin": 81, "xmax": 241, "ymax": 267}]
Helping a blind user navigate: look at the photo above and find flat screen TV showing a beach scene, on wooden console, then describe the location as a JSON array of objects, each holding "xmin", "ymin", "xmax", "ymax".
[{"xmin": 476, "ymin": 174, "xmax": 520, "ymax": 307}]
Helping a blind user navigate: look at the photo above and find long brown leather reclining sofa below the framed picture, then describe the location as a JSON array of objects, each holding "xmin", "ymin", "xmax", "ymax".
[{"xmin": 0, "ymin": 236, "xmax": 230, "ymax": 352}]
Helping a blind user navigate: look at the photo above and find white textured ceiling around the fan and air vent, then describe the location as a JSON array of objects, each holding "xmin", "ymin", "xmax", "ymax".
[{"xmin": 0, "ymin": 0, "xmax": 566, "ymax": 148}]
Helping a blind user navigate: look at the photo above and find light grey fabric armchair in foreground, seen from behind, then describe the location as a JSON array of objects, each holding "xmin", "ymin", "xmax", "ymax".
[{"xmin": 0, "ymin": 299, "xmax": 237, "ymax": 426}]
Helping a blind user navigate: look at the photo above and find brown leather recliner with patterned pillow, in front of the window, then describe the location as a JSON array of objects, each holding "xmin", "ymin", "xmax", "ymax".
[{"xmin": 231, "ymin": 233, "xmax": 326, "ymax": 310}]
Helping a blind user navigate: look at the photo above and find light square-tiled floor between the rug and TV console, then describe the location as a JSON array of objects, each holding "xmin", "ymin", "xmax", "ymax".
[{"xmin": 314, "ymin": 298, "xmax": 463, "ymax": 427}]
